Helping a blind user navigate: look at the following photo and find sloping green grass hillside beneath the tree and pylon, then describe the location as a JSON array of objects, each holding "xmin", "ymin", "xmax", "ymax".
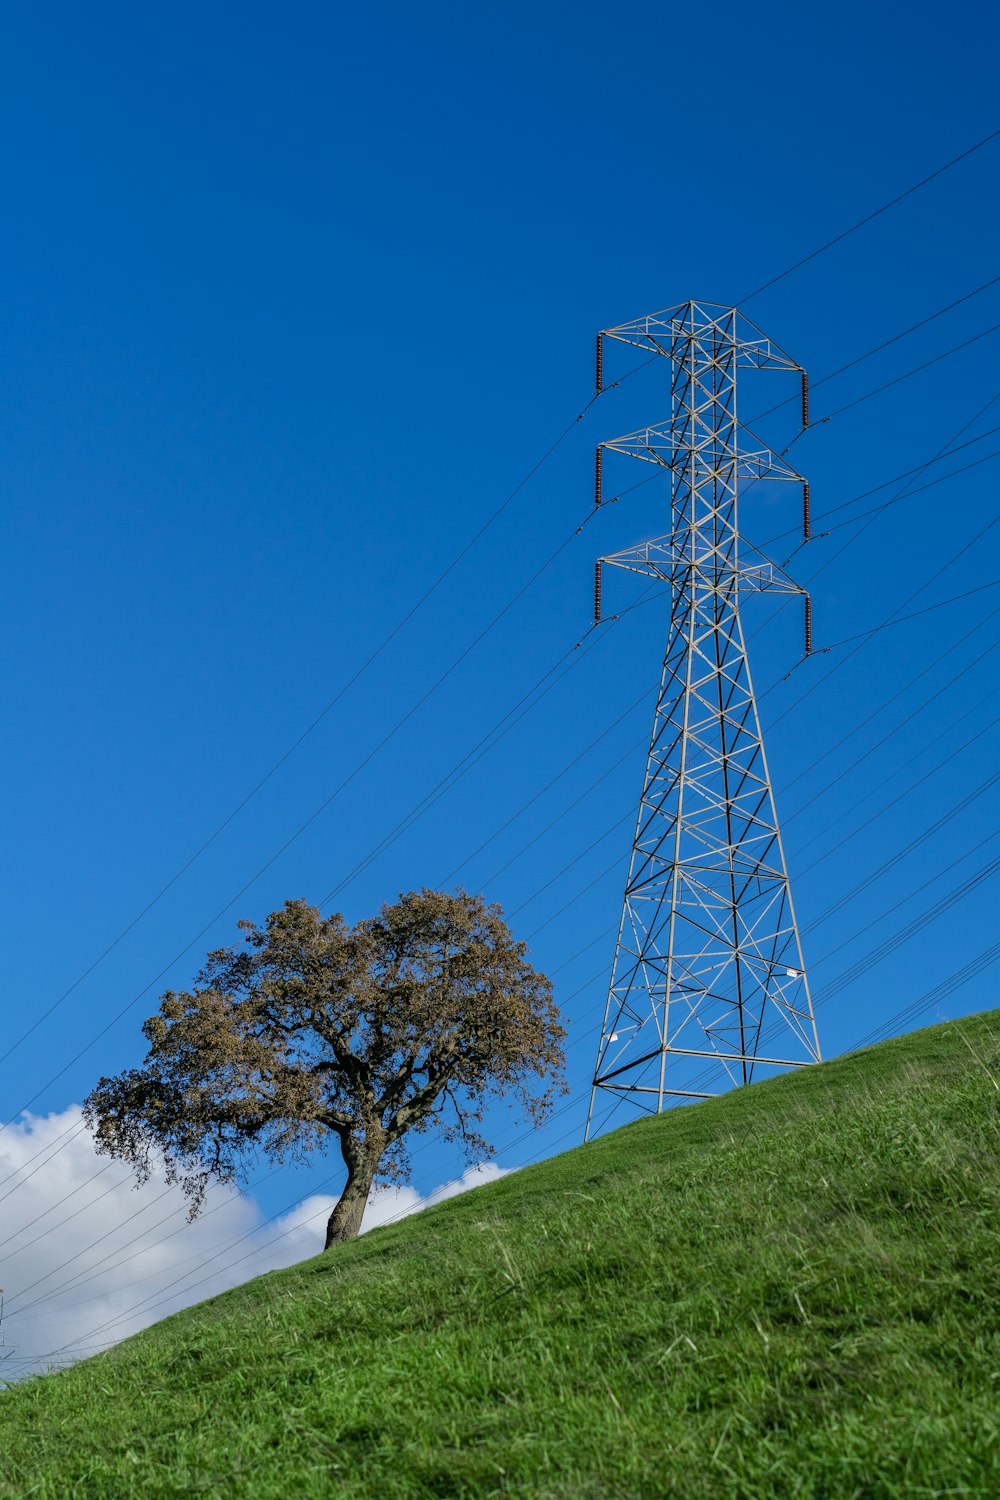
[{"xmin": 0, "ymin": 1011, "xmax": 1000, "ymax": 1500}]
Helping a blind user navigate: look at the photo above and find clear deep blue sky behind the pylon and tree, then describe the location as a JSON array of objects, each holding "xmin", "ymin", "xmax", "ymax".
[{"xmin": 0, "ymin": 3, "xmax": 1000, "ymax": 1374}]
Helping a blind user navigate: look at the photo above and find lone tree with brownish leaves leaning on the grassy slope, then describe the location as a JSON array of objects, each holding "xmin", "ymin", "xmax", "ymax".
[{"xmin": 84, "ymin": 890, "xmax": 565, "ymax": 1250}]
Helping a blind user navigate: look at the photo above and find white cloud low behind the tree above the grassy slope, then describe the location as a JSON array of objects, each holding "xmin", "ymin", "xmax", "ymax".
[{"xmin": 0, "ymin": 1104, "xmax": 505, "ymax": 1380}]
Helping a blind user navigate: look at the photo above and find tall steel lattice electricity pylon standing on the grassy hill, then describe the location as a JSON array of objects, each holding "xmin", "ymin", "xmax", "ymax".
[{"xmin": 586, "ymin": 302, "xmax": 820, "ymax": 1137}]
